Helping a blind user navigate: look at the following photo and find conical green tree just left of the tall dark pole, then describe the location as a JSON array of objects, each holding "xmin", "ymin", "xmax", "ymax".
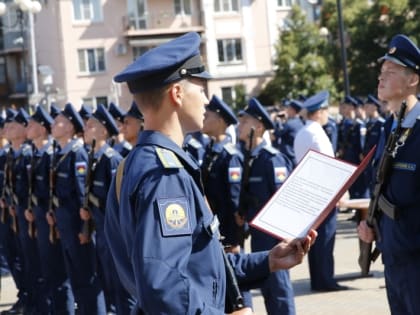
[{"xmin": 259, "ymin": 6, "xmax": 335, "ymax": 104}]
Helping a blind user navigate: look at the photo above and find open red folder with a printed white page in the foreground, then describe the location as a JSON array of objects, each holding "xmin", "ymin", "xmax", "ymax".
[{"xmin": 250, "ymin": 147, "xmax": 375, "ymax": 239}]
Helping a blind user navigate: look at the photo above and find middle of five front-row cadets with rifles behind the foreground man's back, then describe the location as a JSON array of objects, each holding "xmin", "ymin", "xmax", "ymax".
[{"xmin": 49, "ymin": 103, "xmax": 106, "ymax": 315}]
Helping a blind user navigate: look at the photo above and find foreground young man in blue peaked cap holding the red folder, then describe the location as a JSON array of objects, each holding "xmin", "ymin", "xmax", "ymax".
[{"xmin": 105, "ymin": 33, "xmax": 314, "ymax": 314}]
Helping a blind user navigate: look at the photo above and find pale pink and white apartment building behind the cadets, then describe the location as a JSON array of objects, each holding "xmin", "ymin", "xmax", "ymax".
[{"xmin": 0, "ymin": 0, "xmax": 312, "ymax": 108}]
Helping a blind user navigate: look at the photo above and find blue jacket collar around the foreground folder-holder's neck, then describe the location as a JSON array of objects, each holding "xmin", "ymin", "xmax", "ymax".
[{"xmin": 137, "ymin": 130, "xmax": 200, "ymax": 170}]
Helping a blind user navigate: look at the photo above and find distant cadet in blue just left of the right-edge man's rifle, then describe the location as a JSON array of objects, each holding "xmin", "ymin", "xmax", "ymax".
[{"xmin": 363, "ymin": 94, "xmax": 385, "ymax": 193}]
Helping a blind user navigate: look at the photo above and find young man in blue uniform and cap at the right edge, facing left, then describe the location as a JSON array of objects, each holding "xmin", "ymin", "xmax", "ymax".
[{"xmin": 359, "ymin": 35, "xmax": 420, "ymax": 315}]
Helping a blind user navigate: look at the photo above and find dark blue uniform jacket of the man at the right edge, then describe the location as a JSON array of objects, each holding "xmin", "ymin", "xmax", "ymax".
[{"xmin": 378, "ymin": 103, "xmax": 420, "ymax": 264}]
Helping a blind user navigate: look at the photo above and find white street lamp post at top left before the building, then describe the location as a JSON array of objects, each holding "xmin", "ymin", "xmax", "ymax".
[{"xmin": 0, "ymin": 0, "xmax": 42, "ymax": 108}]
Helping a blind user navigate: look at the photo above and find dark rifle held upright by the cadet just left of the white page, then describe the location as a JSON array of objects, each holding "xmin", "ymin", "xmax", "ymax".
[{"xmin": 238, "ymin": 127, "xmax": 255, "ymax": 247}]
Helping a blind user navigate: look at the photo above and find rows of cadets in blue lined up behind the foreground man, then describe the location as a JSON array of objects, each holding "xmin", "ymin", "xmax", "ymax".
[{"xmin": 0, "ymin": 90, "xmax": 386, "ymax": 315}]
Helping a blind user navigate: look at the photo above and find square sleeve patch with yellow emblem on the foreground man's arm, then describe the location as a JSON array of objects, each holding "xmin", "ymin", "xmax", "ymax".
[{"xmin": 158, "ymin": 197, "xmax": 192, "ymax": 236}]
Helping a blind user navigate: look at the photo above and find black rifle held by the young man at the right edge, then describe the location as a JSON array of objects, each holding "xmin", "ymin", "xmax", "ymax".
[{"xmin": 359, "ymin": 101, "xmax": 407, "ymax": 274}]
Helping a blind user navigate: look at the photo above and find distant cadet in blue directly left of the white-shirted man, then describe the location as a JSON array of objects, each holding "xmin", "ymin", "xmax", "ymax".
[{"xmin": 275, "ymin": 99, "xmax": 305, "ymax": 167}]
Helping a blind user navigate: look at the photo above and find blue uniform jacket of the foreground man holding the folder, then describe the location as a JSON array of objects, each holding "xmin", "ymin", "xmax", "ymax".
[{"xmin": 105, "ymin": 131, "xmax": 268, "ymax": 314}]
